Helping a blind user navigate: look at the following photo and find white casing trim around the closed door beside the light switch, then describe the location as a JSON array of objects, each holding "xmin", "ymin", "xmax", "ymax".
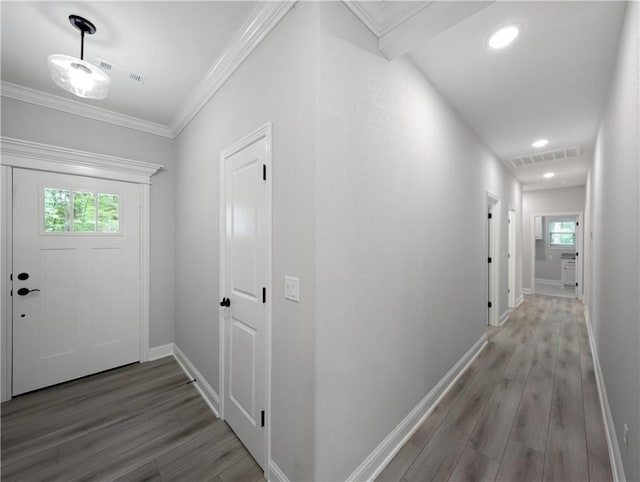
[{"xmin": 218, "ymin": 121, "xmax": 273, "ymax": 473}]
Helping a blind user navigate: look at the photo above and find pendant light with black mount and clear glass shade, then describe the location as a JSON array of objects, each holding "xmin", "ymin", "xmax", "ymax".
[{"xmin": 47, "ymin": 15, "xmax": 111, "ymax": 99}]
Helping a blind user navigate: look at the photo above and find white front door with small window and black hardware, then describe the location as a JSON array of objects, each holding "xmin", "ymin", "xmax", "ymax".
[{"xmin": 12, "ymin": 169, "xmax": 141, "ymax": 395}]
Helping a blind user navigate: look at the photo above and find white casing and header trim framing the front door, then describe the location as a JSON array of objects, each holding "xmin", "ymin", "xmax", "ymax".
[{"xmin": 0, "ymin": 137, "xmax": 162, "ymax": 401}]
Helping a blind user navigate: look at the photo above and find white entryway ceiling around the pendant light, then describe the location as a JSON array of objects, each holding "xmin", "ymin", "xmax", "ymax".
[{"xmin": 0, "ymin": 1, "xmax": 259, "ymax": 126}]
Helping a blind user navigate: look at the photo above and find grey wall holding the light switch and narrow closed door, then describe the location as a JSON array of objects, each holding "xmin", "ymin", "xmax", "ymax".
[{"xmin": 176, "ymin": 3, "xmax": 317, "ymax": 480}]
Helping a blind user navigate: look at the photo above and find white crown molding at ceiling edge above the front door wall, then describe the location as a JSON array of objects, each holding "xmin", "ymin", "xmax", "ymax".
[{"xmin": 0, "ymin": 81, "xmax": 173, "ymax": 137}]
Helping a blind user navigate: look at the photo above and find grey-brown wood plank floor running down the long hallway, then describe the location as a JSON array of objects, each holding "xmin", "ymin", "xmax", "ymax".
[{"xmin": 377, "ymin": 295, "xmax": 612, "ymax": 482}]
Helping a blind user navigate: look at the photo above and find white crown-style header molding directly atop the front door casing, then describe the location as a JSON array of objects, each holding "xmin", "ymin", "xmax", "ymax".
[{"xmin": 0, "ymin": 137, "xmax": 162, "ymax": 184}]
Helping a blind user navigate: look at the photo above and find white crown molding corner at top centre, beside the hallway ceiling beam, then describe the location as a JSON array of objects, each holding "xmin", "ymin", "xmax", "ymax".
[{"xmin": 343, "ymin": 0, "xmax": 433, "ymax": 38}]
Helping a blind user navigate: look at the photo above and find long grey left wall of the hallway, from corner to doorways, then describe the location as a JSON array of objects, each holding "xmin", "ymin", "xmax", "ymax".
[{"xmin": 314, "ymin": 2, "xmax": 521, "ymax": 480}]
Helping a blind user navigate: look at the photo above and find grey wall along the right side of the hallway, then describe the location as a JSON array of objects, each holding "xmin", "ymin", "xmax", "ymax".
[{"xmin": 586, "ymin": 2, "xmax": 640, "ymax": 481}]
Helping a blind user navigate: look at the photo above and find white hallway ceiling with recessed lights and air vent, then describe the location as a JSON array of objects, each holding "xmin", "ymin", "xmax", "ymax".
[{"xmin": 409, "ymin": 1, "xmax": 625, "ymax": 189}]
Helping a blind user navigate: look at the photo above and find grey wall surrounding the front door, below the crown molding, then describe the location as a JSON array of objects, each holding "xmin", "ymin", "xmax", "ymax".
[{"xmin": 1, "ymin": 97, "xmax": 175, "ymax": 347}]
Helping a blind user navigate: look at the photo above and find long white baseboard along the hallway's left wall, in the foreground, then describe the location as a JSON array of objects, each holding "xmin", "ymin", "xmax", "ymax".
[{"xmin": 347, "ymin": 334, "xmax": 487, "ymax": 481}]
